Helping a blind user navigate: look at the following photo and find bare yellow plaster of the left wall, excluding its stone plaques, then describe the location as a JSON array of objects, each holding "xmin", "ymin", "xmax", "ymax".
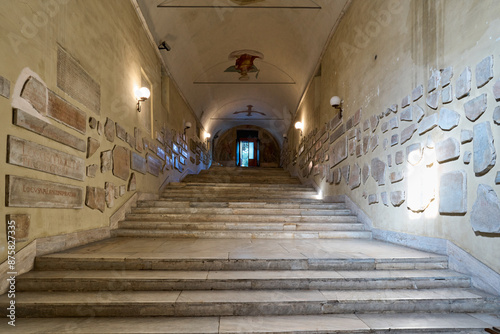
[{"xmin": 0, "ymin": 0, "xmax": 206, "ymax": 262}]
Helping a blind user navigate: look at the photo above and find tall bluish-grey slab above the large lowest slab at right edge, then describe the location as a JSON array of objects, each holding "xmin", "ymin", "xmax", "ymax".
[{"xmin": 472, "ymin": 122, "xmax": 497, "ymax": 176}]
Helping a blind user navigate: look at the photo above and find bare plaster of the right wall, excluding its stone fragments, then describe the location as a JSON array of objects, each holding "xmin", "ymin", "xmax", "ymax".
[{"xmin": 289, "ymin": 0, "xmax": 500, "ymax": 273}]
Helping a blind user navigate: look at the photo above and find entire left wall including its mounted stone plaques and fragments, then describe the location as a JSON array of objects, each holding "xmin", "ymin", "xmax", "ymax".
[{"xmin": 0, "ymin": 0, "xmax": 210, "ymax": 264}]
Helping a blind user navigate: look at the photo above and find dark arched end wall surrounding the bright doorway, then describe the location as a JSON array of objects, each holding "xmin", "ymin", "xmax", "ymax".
[{"xmin": 214, "ymin": 125, "xmax": 280, "ymax": 167}]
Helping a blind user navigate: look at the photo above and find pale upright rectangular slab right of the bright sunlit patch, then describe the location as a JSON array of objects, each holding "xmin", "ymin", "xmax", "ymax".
[{"xmin": 439, "ymin": 170, "xmax": 467, "ymax": 214}]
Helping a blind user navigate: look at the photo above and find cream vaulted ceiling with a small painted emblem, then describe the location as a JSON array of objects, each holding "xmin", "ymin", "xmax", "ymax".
[{"xmin": 137, "ymin": 0, "xmax": 349, "ymax": 140}]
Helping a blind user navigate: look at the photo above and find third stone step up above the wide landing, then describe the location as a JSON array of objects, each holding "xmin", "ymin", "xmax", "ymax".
[{"xmin": 137, "ymin": 200, "xmax": 345, "ymax": 210}]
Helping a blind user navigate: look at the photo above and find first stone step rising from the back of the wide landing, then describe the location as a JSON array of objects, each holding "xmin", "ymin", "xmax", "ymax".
[{"xmin": 111, "ymin": 228, "xmax": 372, "ymax": 239}]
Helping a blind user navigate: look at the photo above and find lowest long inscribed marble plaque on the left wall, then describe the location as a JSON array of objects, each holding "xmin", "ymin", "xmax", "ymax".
[{"xmin": 6, "ymin": 175, "xmax": 84, "ymax": 209}]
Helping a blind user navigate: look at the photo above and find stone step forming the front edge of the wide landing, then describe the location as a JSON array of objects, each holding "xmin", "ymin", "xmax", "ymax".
[{"xmin": 35, "ymin": 254, "xmax": 448, "ymax": 271}]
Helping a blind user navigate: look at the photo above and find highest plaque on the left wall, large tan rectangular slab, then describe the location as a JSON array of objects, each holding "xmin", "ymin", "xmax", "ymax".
[{"xmin": 57, "ymin": 47, "xmax": 101, "ymax": 115}]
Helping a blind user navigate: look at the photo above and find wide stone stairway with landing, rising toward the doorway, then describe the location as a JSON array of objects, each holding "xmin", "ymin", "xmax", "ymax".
[{"xmin": 0, "ymin": 167, "xmax": 500, "ymax": 333}]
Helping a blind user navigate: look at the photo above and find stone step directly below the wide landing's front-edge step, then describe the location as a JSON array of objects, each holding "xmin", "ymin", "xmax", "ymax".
[{"xmin": 16, "ymin": 270, "xmax": 470, "ymax": 292}]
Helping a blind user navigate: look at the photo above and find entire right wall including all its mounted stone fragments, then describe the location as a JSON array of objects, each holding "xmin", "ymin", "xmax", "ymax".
[{"xmin": 284, "ymin": 0, "xmax": 500, "ymax": 273}]
